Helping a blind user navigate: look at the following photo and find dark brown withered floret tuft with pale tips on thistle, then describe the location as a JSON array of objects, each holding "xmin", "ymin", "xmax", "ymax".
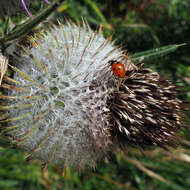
[{"xmin": 107, "ymin": 68, "xmax": 182, "ymax": 148}]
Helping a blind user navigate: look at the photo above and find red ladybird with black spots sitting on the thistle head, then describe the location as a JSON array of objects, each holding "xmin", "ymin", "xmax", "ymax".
[{"xmin": 109, "ymin": 60, "xmax": 126, "ymax": 78}]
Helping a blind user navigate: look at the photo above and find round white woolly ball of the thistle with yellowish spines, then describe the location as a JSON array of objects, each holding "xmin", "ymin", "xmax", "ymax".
[{"xmin": 0, "ymin": 23, "xmax": 128, "ymax": 167}]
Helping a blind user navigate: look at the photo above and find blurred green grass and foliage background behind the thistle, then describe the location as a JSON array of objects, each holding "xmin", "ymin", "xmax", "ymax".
[{"xmin": 0, "ymin": 0, "xmax": 190, "ymax": 190}]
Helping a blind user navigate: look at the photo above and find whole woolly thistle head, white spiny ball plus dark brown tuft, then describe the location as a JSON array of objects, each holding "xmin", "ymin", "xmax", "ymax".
[{"xmin": 0, "ymin": 23, "xmax": 181, "ymax": 168}]
